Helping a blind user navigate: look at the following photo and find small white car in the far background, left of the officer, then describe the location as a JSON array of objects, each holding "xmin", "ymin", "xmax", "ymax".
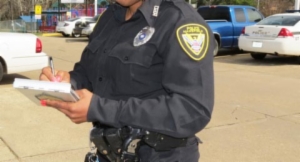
[{"xmin": 55, "ymin": 16, "xmax": 93, "ymax": 37}]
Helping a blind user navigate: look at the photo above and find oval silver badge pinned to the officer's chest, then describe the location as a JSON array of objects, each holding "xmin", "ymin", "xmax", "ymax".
[{"xmin": 133, "ymin": 26, "xmax": 155, "ymax": 47}]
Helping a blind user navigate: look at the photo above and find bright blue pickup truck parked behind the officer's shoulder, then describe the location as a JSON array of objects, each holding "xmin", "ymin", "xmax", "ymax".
[{"xmin": 197, "ymin": 5, "xmax": 264, "ymax": 56}]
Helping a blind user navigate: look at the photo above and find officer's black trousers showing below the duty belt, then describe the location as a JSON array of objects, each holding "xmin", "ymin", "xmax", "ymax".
[{"xmin": 98, "ymin": 137, "xmax": 200, "ymax": 162}]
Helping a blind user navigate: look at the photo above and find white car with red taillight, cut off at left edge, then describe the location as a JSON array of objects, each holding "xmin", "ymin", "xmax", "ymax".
[{"xmin": 0, "ymin": 32, "xmax": 49, "ymax": 81}]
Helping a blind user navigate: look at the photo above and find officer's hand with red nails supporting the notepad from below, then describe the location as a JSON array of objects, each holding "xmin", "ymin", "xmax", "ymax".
[{"xmin": 45, "ymin": 89, "xmax": 93, "ymax": 124}]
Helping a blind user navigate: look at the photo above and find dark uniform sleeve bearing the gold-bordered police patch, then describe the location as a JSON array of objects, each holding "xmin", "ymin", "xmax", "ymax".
[{"xmin": 88, "ymin": 13, "xmax": 214, "ymax": 137}]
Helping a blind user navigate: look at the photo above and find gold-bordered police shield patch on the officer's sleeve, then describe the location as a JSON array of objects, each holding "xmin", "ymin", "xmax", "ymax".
[{"xmin": 176, "ymin": 24, "xmax": 209, "ymax": 61}]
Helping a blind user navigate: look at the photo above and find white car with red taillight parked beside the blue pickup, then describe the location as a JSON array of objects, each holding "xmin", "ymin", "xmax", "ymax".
[{"xmin": 238, "ymin": 13, "xmax": 300, "ymax": 59}]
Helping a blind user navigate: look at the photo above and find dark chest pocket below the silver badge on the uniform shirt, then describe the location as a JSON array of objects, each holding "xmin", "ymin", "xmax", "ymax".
[{"xmin": 106, "ymin": 43, "xmax": 158, "ymax": 96}]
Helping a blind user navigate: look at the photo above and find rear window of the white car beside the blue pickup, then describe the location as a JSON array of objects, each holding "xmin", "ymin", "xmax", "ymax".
[{"xmin": 257, "ymin": 15, "xmax": 300, "ymax": 26}]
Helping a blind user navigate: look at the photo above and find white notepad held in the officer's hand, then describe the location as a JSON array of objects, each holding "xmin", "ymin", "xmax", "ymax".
[{"xmin": 13, "ymin": 78, "xmax": 79, "ymax": 105}]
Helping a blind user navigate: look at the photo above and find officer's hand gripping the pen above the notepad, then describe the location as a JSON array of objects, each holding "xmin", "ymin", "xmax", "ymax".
[{"xmin": 40, "ymin": 66, "xmax": 70, "ymax": 83}]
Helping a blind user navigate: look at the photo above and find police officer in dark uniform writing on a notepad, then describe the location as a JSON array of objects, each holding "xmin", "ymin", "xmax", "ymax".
[{"xmin": 40, "ymin": 0, "xmax": 215, "ymax": 162}]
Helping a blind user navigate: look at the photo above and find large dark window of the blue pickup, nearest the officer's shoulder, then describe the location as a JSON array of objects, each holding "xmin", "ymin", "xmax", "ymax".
[{"xmin": 198, "ymin": 7, "xmax": 230, "ymax": 21}]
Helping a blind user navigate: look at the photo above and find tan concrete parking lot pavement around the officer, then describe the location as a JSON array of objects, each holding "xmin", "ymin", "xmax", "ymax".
[{"xmin": 0, "ymin": 36, "xmax": 300, "ymax": 162}]
